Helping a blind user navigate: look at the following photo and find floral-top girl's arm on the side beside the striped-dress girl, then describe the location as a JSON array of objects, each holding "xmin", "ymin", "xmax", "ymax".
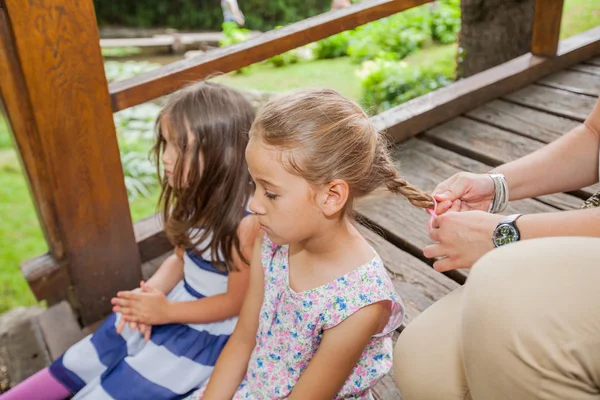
[{"xmin": 203, "ymin": 235, "xmax": 264, "ymax": 400}]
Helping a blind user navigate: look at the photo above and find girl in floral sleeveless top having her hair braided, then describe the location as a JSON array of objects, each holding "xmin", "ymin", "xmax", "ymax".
[{"xmin": 192, "ymin": 90, "xmax": 433, "ymax": 400}]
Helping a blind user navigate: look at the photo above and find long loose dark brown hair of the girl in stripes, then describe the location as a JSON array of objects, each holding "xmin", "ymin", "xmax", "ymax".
[{"xmin": 153, "ymin": 82, "xmax": 254, "ymax": 271}]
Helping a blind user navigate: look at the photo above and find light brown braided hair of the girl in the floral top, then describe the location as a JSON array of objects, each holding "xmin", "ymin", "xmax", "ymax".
[{"xmin": 250, "ymin": 89, "xmax": 433, "ymax": 209}]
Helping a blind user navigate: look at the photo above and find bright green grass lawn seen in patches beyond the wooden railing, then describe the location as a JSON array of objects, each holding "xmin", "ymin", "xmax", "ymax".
[{"xmin": 0, "ymin": 0, "xmax": 600, "ymax": 313}]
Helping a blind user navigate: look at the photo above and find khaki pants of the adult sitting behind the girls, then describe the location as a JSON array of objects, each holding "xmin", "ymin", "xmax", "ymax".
[{"xmin": 394, "ymin": 238, "xmax": 600, "ymax": 400}]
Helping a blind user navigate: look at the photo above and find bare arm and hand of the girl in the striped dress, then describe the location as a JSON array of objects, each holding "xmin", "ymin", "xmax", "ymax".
[{"xmin": 115, "ymin": 217, "xmax": 258, "ymax": 325}]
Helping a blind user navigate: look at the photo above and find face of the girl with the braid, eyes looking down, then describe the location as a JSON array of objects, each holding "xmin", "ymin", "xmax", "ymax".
[{"xmin": 246, "ymin": 139, "xmax": 325, "ymax": 245}]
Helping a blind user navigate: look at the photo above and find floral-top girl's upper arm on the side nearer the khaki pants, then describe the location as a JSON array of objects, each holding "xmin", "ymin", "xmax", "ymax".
[{"xmin": 289, "ymin": 302, "xmax": 390, "ymax": 400}]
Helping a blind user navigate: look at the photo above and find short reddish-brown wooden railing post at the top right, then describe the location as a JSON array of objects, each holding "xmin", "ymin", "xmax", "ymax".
[{"xmin": 531, "ymin": 0, "xmax": 563, "ymax": 57}]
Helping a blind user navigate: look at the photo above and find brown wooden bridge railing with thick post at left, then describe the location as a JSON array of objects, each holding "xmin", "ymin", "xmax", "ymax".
[{"xmin": 0, "ymin": 0, "xmax": 600, "ymax": 323}]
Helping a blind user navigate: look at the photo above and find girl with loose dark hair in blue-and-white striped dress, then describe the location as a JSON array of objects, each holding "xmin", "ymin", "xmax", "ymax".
[{"xmin": 1, "ymin": 83, "xmax": 259, "ymax": 400}]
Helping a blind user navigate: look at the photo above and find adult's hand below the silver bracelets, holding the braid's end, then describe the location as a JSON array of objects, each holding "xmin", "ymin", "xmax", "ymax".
[{"xmin": 432, "ymin": 172, "xmax": 494, "ymax": 215}]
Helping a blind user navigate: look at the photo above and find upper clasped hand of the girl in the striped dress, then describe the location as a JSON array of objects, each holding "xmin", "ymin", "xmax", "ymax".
[{"xmin": 111, "ymin": 282, "xmax": 170, "ymax": 325}]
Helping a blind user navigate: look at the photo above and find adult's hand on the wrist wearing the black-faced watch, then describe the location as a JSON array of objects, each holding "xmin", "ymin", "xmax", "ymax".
[{"xmin": 423, "ymin": 209, "xmax": 504, "ymax": 272}]
